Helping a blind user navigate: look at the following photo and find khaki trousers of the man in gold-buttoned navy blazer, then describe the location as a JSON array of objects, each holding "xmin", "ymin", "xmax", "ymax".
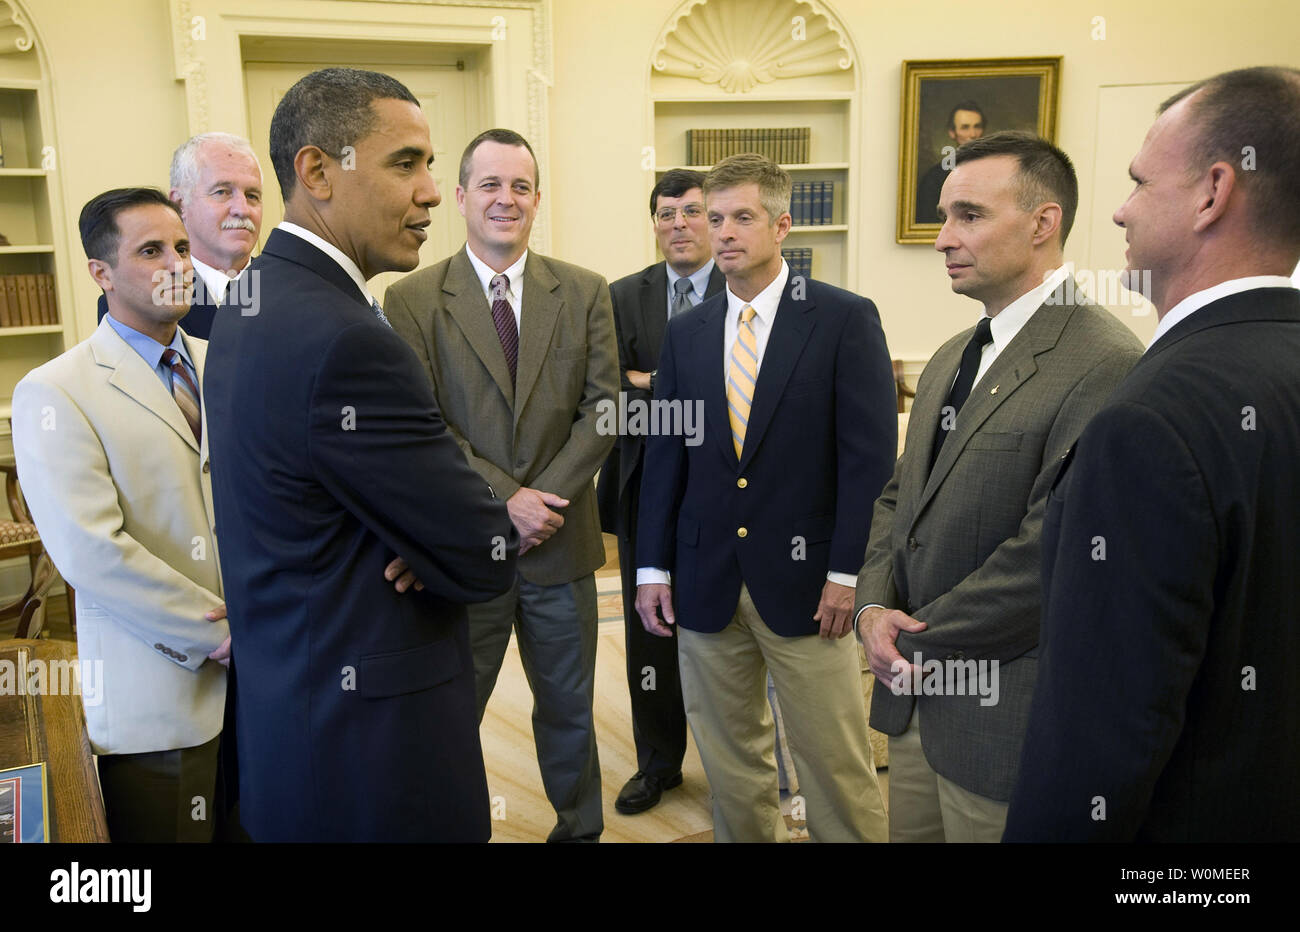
[{"xmin": 677, "ymin": 586, "xmax": 888, "ymax": 841}]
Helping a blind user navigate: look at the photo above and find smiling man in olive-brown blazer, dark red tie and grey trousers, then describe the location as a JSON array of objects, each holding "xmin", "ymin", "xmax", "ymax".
[{"xmin": 384, "ymin": 130, "xmax": 619, "ymax": 841}]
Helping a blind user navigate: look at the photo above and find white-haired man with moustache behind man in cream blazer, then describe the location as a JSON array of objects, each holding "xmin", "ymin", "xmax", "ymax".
[{"xmin": 99, "ymin": 133, "xmax": 261, "ymax": 339}]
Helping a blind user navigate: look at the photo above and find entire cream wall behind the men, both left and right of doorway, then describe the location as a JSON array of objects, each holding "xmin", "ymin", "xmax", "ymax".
[{"xmin": 17, "ymin": 0, "xmax": 1300, "ymax": 359}]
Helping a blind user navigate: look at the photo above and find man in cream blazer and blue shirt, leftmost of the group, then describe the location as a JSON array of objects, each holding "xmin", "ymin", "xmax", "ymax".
[{"xmin": 13, "ymin": 188, "xmax": 230, "ymax": 842}]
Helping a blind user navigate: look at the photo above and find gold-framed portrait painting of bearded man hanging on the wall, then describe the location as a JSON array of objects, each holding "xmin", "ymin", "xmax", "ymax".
[{"xmin": 896, "ymin": 56, "xmax": 1061, "ymax": 243}]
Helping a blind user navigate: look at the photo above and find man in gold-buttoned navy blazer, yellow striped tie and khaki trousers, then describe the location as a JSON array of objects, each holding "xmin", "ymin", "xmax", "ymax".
[{"xmin": 637, "ymin": 155, "xmax": 898, "ymax": 841}]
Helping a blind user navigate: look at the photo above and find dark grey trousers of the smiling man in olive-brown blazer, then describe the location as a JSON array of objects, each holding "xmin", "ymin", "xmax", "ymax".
[{"xmin": 468, "ymin": 575, "xmax": 605, "ymax": 841}]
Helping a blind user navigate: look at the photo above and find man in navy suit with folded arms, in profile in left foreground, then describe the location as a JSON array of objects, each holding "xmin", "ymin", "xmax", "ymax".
[{"xmin": 204, "ymin": 69, "xmax": 519, "ymax": 841}]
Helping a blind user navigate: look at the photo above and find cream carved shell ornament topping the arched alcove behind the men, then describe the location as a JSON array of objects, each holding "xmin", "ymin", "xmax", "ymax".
[{"xmin": 653, "ymin": 0, "xmax": 853, "ymax": 94}]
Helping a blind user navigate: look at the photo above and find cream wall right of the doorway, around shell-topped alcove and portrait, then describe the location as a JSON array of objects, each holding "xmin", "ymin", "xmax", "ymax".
[{"xmin": 550, "ymin": 0, "xmax": 1300, "ymax": 359}]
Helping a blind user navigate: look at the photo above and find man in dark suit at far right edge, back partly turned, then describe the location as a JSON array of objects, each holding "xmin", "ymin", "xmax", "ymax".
[{"xmin": 1004, "ymin": 68, "xmax": 1300, "ymax": 841}]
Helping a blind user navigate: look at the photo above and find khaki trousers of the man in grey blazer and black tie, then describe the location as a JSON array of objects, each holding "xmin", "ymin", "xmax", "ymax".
[{"xmin": 889, "ymin": 708, "xmax": 1008, "ymax": 844}]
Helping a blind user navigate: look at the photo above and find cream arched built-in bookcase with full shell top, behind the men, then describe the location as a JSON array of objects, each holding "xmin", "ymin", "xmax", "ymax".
[{"xmin": 646, "ymin": 0, "xmax": 862, "ymax": 290}]
